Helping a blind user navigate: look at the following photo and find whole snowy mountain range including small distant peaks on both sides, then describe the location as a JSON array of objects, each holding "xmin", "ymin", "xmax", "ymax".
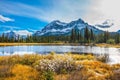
[{"xmin": 6, "ymin": 19, "xmax": 120, "ymax": 36}]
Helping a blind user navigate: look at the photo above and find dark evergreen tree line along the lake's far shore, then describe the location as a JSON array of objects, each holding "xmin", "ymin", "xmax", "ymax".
[{"xmin": 0, "ymin": 27, "xmax": 120, "ymax": 44}]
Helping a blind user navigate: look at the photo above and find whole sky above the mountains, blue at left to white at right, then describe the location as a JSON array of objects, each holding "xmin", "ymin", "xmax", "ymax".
[{"xmin": 0, "ymin": 0, "xmax": 120, "ymax": 33}]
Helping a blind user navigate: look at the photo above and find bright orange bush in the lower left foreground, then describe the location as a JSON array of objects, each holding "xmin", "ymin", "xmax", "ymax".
[{"xmin": 5, "ymin": 64, "xmax": 39, "ymax": 80}]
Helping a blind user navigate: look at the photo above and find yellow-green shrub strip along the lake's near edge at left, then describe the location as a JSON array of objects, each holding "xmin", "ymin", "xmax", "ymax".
[{"xmin": 0, "ymin": 54, "xmax": 43, "ymax": 66}]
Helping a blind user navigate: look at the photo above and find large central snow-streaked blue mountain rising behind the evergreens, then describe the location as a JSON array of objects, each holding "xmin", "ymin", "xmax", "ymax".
[{"xmin": 34, "ymin": 19, "xmax": 103, "ymax": 36}]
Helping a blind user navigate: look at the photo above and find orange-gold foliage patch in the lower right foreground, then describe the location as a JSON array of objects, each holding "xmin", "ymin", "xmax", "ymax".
[{"xmin": 76, "ymin": 60, "xmax": 113, "ymax": 80}]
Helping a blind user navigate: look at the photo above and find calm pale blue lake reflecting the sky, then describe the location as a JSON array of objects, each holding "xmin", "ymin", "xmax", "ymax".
[{"xmin": 0, "ymin": 45, "xmax": 120, "ymax": 64}]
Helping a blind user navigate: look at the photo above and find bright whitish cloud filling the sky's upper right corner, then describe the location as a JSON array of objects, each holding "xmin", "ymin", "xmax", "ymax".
[{"xmin": 84, "ymin": 0, "xmax": 120, "ymax": 31}]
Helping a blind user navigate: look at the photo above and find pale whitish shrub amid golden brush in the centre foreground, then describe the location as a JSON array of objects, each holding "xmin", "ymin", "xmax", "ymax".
[{"xmin": 36, "ymin": 59, "xmax": 75, "ymax": 73}]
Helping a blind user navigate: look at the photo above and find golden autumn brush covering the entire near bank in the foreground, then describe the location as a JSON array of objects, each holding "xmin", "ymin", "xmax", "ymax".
[{"xmin": 0, "ymin": 52, "xmax": 120, "ymax": 80}]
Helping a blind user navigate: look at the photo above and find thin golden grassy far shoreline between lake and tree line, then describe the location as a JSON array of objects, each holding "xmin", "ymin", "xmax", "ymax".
[{"xmin": 0, "ymin": 43, "xmax": 120, "ymax": 48}]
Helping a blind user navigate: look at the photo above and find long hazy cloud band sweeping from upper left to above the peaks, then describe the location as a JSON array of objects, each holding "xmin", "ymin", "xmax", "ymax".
[{"xmin": 0, "ymin": 0, "xmax": 89, "ymax": 22}]
